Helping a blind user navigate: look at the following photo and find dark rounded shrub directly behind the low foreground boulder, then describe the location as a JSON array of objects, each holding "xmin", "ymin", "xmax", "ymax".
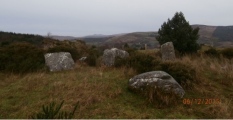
[{"xmin": 160, "ymin": 62, "xmax": 196, "ymax": 87}]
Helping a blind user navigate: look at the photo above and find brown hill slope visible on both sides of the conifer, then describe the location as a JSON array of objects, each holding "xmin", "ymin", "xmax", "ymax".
[{"xmin": 77, "ymin": 25, "xmax": 233, "ymax": 48}]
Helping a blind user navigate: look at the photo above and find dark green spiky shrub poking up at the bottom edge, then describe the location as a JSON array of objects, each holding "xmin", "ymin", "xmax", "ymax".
[{"xmin": 31, "ymin": 101, "xmax": 78, "ymax": 119}]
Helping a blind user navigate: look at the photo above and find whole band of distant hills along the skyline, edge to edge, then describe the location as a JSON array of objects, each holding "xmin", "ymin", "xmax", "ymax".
[{"xmin": 0, "ymin": 25, "xmax": 233, "ymax": 49}]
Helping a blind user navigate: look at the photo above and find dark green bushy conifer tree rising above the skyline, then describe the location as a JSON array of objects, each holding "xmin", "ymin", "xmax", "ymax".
[{"xmin": 156, "ymin": 12, "xmax": 199, "ymax": 54}]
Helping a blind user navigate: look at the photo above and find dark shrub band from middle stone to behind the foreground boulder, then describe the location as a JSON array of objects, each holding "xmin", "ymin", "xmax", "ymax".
[{"xmin": 115, "ymin": 52, "xmax": 196, "ymax": 87}]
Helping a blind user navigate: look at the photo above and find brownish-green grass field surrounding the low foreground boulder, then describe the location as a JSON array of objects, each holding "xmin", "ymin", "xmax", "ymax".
[{"xmin": 0, "ymin": 51, "xmax": 233, "ymax": 119}]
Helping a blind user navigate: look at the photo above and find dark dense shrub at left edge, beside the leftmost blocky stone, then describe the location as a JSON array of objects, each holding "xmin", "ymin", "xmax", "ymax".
[{"xmin": 0, "ymin": 43, "xmax": 45, "ymax": 73}]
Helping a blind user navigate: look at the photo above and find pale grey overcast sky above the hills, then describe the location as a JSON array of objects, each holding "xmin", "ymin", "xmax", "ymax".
[{"xmin": 0, "ymin": 0, "xmax": 233, "ymax": 37}]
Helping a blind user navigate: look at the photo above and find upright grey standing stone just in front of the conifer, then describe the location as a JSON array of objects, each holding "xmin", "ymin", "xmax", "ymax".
[{"xmin": 161, "ymin": 42, "xmax": 176, "ymax": 60}]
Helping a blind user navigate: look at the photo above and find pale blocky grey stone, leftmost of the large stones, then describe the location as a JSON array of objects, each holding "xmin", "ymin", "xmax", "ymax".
[{"xmin": 44, "ymin": 52, "xmax": 74, "ymax": 71}]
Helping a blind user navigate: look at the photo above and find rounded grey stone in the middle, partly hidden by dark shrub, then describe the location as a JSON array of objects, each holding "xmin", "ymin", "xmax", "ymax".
[{"xmin": 103, "ymin": 48, "xmax": 129, "ymax": 66}]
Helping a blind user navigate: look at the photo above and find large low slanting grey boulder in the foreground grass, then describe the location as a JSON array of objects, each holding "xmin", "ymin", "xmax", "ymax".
[{"xmin": 128, "ymin": 71, "xmax": 185, "ymax": 98}]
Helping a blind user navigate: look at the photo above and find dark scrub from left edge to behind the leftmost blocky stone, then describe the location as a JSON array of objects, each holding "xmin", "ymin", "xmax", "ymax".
[{"xmin": 0, "ymin": 32, "xmax": 93, "ymax": 74}]
